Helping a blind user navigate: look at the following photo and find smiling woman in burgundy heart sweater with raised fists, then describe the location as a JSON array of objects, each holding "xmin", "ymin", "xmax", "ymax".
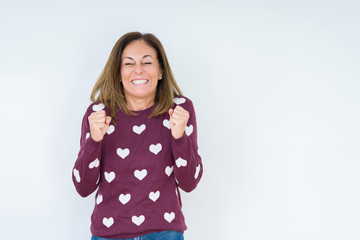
[{"xmin": 72, "ymin": 32, "xmax": 203, "ymax": 240}]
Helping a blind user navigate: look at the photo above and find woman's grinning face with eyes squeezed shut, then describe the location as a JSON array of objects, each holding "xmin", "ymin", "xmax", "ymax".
[{"xmin": 120, "ymin": 40, "xmax": 162, "ymax": 100}]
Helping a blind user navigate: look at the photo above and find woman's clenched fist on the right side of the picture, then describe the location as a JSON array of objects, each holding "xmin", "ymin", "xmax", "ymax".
[{"xmin": 169, "ymin": 106, "xmax": 189, "ymax": 139}]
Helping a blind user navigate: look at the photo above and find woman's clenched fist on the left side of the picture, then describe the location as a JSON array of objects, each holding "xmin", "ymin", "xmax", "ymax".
[{"xmin": 88, "ymin": 110, "xmax": 111, "ymax": 142}]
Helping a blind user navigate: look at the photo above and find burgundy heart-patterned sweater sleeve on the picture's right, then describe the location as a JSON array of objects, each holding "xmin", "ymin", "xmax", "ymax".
[{"xmin": 172, "ymin": 99, "xmax": 203, "ymax": 192}]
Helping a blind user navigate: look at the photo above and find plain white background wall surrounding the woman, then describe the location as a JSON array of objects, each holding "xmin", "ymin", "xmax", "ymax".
[{"xmin": 0, "ymin": 0, "xmax": 360, "ymax": 240}]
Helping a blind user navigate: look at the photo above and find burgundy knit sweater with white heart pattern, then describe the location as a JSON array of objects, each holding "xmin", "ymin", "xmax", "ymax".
[{"xmin": 72, "ymin": 96, "xmax": 203, "ymax": 239}]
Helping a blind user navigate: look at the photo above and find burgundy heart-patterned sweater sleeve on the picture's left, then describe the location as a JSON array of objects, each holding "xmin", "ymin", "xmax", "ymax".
[{"xmin": 72, "ymin": 106, "xmax": 102, "ymax": 197}]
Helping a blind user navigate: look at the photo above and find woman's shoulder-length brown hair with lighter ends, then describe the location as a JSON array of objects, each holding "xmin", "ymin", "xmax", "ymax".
[{"xmin": 90, "ymin": 32, "xmax": 183, "ymax": 119}]
